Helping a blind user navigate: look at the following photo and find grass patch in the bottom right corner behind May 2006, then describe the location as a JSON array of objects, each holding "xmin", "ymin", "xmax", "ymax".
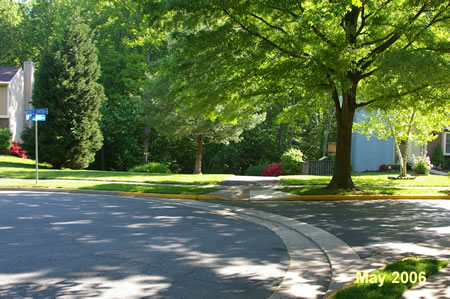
[{"xmin": 332, "ymin": 258, "xmax": 448, "ymax": 299}]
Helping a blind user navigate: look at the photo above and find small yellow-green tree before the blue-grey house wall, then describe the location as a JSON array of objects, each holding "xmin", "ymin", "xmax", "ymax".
[{"xmin": 354, "ymin": 100, "xmax": 450, "ymax": 177}]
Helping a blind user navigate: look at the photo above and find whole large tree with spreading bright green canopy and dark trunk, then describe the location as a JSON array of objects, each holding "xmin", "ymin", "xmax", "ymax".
[{"xmin": 144, "ymin": 0, "xmax": 450, "ymax": 189}]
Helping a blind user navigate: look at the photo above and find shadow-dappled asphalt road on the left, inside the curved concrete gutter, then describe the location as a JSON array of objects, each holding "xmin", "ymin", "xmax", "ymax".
[{"xmin": 0, "ymin": 192, "xmax": 288, "ymax": 298}]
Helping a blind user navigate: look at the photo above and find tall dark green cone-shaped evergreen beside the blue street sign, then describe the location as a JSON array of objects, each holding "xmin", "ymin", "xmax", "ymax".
[{"xmin": 33, "ymin": 14, "xmax": 105, "ymax": 169}]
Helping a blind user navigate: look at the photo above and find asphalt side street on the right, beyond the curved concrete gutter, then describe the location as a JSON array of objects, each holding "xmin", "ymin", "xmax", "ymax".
[{"xmin": 220, "ymin": 200, "xmax": 450, "ymax": 258}]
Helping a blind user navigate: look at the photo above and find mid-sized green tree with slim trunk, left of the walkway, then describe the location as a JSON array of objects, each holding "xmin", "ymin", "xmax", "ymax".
[{"xmin": 143, "ymin": 76, "xmax": 265, "ymax": 174}]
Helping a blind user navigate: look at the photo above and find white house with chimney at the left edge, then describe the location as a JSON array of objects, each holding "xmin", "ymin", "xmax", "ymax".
[{"xmin": 0, "ymin": 61, "xmax": 34, "ymax": 141}]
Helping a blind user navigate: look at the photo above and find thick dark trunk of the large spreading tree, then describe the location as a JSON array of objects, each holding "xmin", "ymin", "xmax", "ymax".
[{"xmin": 327, "ymin": 91, "xmax": 357, "ymax": 191}]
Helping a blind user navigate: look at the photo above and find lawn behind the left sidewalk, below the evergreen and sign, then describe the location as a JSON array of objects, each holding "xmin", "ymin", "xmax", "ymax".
[{"xmin": 0, "ymin": 156, "xmax": 231, "ymax": 185}]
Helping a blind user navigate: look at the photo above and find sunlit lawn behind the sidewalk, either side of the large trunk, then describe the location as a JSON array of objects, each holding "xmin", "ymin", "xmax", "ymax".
[{"xmin": 280, "ymin": 173, "xmax": 450, "ymax": 187}]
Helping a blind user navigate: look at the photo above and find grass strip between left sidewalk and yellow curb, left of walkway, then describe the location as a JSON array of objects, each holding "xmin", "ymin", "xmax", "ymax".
[{"xmin": 0, "ymin": 180, "xmax": 218, "ymax": 195}]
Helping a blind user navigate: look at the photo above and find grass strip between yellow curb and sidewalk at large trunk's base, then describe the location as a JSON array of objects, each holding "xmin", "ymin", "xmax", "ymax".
[{"xmin": 281, "ymin": 187, "xmax": 450, "ymax": 195}]
